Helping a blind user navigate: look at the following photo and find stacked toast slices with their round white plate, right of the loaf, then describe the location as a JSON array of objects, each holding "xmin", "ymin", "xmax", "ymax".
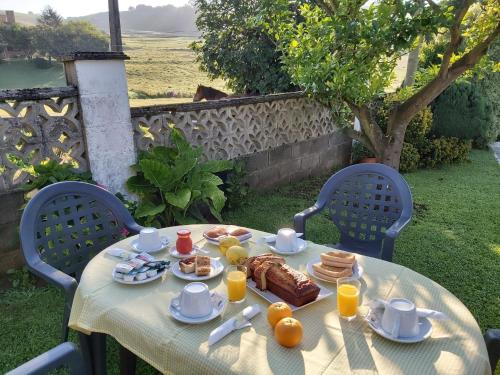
[{"xmin": 306, "ymin": 251, "xmax": 364, "ymax": 283}]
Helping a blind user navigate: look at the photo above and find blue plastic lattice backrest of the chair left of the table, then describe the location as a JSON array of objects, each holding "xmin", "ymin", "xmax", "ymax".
[{"xmin": 20, "ymin": 182, "xmax": 133, "ymax": 280}]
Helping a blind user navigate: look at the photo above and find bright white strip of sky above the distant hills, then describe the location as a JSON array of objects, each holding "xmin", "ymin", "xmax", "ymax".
[{"xmin": 0, "ymin": 0, "xmax": 188, "ymax": 17}]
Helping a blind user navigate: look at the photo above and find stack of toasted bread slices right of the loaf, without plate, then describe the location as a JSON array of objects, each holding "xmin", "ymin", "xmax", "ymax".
[{"xmin": 312, "ymin": 251, "xmax": 356, "ymax": 282}]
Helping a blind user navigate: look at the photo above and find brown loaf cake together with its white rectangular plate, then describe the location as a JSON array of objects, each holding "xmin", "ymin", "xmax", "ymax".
[{"xmin": 245, "ymin": 253, "xmax": 333, "ymax": 311}]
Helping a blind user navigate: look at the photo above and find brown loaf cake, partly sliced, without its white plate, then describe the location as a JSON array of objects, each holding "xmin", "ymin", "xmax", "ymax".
[{"xmin": 245, "ymin": 254, "xmax": 320, "ymax": 306}]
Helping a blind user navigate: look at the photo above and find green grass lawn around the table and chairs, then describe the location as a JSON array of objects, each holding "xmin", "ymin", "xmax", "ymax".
[{"xmin": 0, "ymin": 151, "xmax": 500, "ymax": 374}]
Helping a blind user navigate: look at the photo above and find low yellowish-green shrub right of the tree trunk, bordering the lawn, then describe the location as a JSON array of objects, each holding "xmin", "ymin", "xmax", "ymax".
[{"xmin": 419, "ymin": 137, "xmax": 472, "ymax": 168}]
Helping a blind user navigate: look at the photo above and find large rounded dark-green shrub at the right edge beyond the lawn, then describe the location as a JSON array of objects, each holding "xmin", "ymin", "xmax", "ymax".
[{"xmin": 432, "ymin": 81, "xmax": 496, "ymax": 148}]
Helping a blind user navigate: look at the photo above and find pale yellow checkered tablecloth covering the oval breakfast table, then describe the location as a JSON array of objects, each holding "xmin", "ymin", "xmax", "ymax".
[{"xmin": 69, "ymin": 225, "xmax": 490, "ymax": 375}]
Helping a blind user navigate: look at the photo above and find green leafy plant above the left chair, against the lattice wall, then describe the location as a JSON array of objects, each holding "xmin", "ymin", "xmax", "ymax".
[{"xmin": 22, "ymin": 160, "xmax": 94, "ymax": 191}]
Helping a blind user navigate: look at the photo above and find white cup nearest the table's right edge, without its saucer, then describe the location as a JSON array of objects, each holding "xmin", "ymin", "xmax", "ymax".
[{"xmin": 382, "ymin": 298, "xmax": 418, "ymax": 338}]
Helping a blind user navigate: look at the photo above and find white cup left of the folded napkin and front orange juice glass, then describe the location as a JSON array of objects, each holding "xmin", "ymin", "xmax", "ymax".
[{"xmin": 172, "ymin": 282, "xmax": 213, "ymax": 318}]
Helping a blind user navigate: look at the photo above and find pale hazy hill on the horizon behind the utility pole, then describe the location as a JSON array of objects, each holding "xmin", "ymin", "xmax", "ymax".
[{"xmin": 70, "ymin": 5, "xmax": 199, "ymax": 36}]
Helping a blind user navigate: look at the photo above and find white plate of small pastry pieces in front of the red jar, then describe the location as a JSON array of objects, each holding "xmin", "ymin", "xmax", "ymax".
[{"xmin": 172, "ymin": 255, "xmax": 224, "ymax": 281}]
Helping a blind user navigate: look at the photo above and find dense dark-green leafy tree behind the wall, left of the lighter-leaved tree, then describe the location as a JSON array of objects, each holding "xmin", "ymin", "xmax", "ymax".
[{"xmin": 191, "ymin": 0, "xmax": 294, "ymax": 94}]
